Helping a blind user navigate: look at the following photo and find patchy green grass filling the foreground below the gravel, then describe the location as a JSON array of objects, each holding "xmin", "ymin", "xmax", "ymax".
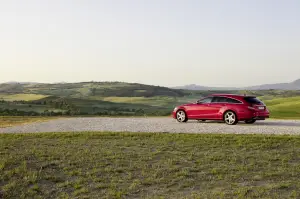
[{"xmin": 0, "ymin": 132, "xmax": 300, "ymax": 199}]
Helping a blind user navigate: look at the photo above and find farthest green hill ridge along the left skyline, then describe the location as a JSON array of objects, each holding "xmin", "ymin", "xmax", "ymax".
[{"xmin": 0, "ymin": 82, "xmax": 184, "ymax": 97}]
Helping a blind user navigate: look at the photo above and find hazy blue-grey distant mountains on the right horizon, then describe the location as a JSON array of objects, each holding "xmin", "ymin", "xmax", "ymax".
[{"xmin": 173, "ymin": 79, "xmax": 300, "ymax": 90}]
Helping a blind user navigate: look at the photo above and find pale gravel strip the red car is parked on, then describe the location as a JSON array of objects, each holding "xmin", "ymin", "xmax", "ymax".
[{"xmin": 0, "ymin": 117, "xmax": 300, "ymax": 134}]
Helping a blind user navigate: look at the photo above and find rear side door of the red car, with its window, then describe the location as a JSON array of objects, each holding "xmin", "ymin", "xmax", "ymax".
[{"xmin": 208, "ymin": 96, "xmax": 227, "ymax": 119}]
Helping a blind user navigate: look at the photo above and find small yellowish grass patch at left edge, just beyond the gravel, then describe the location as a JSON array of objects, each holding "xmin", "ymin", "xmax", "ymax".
[{"xmin": 0, "ymin": 116, "xmax": 55, "ymax": 128}]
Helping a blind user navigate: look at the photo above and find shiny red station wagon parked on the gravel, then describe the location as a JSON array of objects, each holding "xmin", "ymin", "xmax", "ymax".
[{"xmin": 172, "ymin": 94, "xmax": 269, "ymax": 125}]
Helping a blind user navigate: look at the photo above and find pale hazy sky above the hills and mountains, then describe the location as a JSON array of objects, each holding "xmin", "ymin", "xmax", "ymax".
[{"xmin": 0, "ymin": 0, "xmax": 300, "ymax": 86}]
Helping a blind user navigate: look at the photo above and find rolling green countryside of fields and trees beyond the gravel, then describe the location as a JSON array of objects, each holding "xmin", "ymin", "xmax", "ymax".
[{"xmin": 0, "ymin": 82, "xmax": 300, "ymax": 118}]
